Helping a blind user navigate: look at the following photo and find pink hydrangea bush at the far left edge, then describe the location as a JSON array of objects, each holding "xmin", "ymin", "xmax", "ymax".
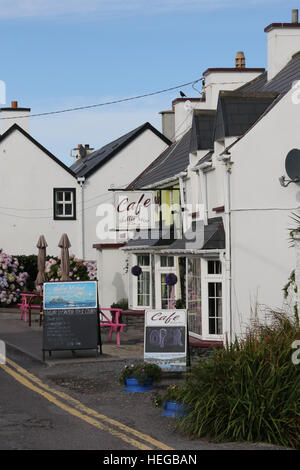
[{"xmin": 0, "ymin": 250, "xmax": 28, "ymax": 305}]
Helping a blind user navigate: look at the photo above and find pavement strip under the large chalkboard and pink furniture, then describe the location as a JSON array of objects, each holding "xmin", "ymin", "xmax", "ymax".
[{"xmin": 0, "ymin": 309, "xmax": 144, "ymax": 366}]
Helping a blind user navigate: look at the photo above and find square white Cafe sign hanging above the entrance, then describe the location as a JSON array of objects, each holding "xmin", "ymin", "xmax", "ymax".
[{"xmin": 115, "ymin": 191, "xmax": 155, "ymax": 230}]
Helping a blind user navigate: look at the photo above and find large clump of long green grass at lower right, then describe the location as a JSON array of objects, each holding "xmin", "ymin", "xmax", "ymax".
[{"xmin": 178, "ymin": 313, "xmax": 300, "ymax": 449}]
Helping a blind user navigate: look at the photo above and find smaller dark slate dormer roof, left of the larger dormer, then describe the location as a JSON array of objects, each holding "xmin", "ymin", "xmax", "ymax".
[{"xmin": 190, "ymin": 110, "xmax": 216, "ymax": 152}]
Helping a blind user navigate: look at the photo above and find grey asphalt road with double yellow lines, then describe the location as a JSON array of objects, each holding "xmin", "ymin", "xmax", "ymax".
[{"xmin": 0, "ymin": 348, "xmax": 286, "ymax": 451}]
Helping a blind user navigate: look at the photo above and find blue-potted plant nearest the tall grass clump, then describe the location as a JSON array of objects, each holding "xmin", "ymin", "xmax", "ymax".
[{"xmin": 152, "ymin": 385, "xmax": 187, "ymax": 418}]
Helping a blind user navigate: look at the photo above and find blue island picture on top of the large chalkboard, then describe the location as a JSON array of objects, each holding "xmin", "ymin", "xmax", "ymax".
[{"xmin": 44, "ymin": 281, "xmax": 97, "ymax": 310}]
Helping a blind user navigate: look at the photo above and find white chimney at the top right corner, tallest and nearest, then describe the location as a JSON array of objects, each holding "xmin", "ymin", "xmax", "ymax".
[{"xmin": 265, "ymin": 10, "xmax": 300, "ymax": 80}]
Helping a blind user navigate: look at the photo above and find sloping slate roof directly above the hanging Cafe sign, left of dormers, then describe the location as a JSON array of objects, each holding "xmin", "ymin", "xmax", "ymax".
[{"xmin": 127, "ymin": 129, "xmax": 191, "ymax": 189}]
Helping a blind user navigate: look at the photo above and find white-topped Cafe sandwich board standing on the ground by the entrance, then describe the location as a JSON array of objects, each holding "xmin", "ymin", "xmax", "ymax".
[{"xmin": 144, "ymin": 310, "xmax": 187, "ymax": 371}]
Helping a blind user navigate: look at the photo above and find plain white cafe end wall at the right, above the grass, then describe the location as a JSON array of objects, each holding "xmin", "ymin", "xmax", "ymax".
[{"xmin": 226, "ymin": 91, "xmax": 300, "ymax": 331}]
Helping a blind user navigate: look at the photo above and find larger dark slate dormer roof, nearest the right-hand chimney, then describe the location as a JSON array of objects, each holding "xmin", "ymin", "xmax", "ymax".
[{"xmin": 214, "ymin": 91, "xmax": 278, "ymax": 140}]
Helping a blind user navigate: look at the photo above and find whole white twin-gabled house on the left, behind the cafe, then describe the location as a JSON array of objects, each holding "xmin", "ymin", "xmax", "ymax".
[{"xmin": 0, "ymin": 101, "xmax": 171, "ymax": 307}]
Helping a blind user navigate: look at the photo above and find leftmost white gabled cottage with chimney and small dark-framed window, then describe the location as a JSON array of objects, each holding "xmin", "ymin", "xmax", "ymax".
[{"xmin": 0, "ymin": 101, "xmax": 80, "ymax": 255}]
